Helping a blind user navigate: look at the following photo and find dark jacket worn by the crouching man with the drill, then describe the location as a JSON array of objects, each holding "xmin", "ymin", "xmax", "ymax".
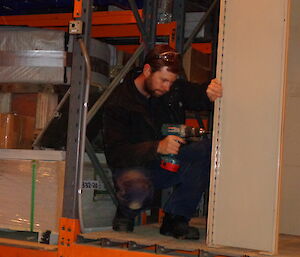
[{"xmin": 103, "ymin": 69, "xmax": 211, "ymax": 168}]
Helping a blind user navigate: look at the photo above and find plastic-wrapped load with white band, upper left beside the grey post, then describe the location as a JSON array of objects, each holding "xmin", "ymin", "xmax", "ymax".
[{"xmin": 0, "ymin": 27, "xmax": 65, "ymax": 84}]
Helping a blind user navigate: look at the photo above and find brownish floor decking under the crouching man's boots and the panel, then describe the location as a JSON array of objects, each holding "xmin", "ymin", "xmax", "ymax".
[{"xmin": 83, "ymin": 218, "xmax": 300, "ymax": 257}]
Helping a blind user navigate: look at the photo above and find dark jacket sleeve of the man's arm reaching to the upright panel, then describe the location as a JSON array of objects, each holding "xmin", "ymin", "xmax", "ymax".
[{"xmin": 174, "ymin": 79, "xmax": 212, "ymax": 111}]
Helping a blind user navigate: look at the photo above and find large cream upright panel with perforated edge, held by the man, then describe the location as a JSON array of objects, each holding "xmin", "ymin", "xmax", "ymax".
[{"xmin": 208, "ymin": 0, "xmax": 288, "ymax": 252}]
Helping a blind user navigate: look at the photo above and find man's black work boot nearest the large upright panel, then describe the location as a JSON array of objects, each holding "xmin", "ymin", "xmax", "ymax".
[{"xmin": 160, "ymin": 213, "xmax": 199, "ymax": 240}]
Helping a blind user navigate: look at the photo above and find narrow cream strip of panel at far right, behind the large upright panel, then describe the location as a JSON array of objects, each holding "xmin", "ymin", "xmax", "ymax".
[{"xmin": 280, "ymin": 0, "xmax": 300, "ymax": 235}]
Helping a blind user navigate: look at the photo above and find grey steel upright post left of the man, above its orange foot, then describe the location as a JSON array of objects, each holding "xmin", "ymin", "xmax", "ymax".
[{"xmin": 63, "ymin": 0, "xmax": 92, "ymax": 219}]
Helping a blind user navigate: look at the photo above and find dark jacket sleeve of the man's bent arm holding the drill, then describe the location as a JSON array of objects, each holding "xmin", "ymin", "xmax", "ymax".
[{"xmin": 103, "ymin": 102, "xmax": 159, "ymax": 168}]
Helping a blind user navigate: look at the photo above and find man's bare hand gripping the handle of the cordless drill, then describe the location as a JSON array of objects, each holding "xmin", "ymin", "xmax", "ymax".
[{"xmin": 157, "ymin": 135, "xmax": 185, "ymax": 154}]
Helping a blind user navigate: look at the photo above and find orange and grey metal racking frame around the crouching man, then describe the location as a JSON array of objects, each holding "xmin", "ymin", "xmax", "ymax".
[{"xmin": 0, "ymin": 0, "xmax": 218, "ymax": 257}]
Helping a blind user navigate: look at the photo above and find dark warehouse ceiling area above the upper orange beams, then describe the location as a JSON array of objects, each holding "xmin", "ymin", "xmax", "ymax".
[{"xmin": 0, "ymin": 0, "xmax": 216, "ymax": 16}]
